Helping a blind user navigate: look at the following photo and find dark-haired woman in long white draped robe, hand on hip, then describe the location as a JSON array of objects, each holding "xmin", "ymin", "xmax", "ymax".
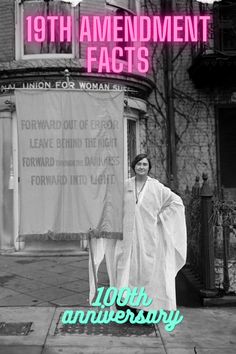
[{"xmin": 115, "ymin": 154, "xmax": 186, "ymax": 311}]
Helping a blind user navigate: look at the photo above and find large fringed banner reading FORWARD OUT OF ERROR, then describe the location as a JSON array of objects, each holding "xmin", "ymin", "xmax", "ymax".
[{"xmin": 16, "ymin": 90, "xmax": 124, "ymax": 240}]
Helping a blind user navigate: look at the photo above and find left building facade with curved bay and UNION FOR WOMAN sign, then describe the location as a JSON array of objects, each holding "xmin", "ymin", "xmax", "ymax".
[{"xmin": 0, "ymin": 0, "xmax": 153, "ymax": 250}]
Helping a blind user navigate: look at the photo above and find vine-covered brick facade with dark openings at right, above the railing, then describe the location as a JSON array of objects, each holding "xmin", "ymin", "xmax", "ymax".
[{"xmin": 145, "ymin": 0, "xmax": 236, "ymax": 200}]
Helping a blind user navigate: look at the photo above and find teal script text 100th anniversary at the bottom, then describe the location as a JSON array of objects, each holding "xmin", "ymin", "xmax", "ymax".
[{"xmin": 61, "ymin": 287, "xmax": 184, "ymax": 332}]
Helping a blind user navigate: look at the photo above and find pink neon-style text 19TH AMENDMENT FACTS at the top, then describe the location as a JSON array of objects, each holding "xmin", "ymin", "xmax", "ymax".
[{"xmin": 25, "ymin": 15, "xmax": 211, "ymax": 73}]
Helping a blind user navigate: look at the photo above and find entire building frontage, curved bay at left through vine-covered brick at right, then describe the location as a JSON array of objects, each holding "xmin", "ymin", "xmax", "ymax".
[{"xmin": 0, "ymin": 0, "xmax": 236, "ymax": 262}]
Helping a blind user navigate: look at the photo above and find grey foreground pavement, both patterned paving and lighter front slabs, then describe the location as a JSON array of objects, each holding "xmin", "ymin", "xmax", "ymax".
[{"xmin": 0, "ymin": 253, "xmax": 236, "ymax": 354}]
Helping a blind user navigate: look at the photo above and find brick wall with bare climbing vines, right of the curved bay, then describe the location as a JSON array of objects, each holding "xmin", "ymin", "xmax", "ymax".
[{"xmin": 144, "ymin": 0, "xmax": 219, "ymax": 192}]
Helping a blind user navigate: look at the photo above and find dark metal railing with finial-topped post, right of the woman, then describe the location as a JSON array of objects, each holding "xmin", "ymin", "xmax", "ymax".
[{"xmin": 184, "ymin": 174, "xmax": 236, "ymax": 297}]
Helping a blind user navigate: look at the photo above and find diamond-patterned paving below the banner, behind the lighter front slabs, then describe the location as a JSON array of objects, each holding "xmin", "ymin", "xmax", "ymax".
[{"xmin": 0, "ymin": 255, "xmax": 92, "ymax": 307}]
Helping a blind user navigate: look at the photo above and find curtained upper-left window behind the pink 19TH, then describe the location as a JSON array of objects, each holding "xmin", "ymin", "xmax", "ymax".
[{"xmin": 22, "ymin": 0, "xmax": 72, "ymax": 55}]
